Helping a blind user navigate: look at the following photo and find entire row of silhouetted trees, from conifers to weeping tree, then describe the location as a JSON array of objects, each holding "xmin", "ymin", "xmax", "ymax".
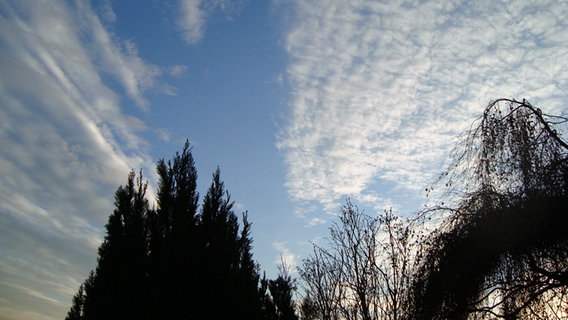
[{"xmin": 67, "ymin": 99, "xmax": 568, "ymax": 320}]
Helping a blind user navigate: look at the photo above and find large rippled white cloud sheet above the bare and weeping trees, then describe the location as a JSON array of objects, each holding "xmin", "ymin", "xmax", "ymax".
[{"xmin": 277, "ymin": 0, "xmax": 568, "ymax": 218}]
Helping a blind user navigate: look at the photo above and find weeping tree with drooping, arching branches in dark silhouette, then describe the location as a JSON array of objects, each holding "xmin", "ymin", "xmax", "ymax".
[{"xmin": 411, "ymin": 99, "xmax": 568, "ymax": 319}]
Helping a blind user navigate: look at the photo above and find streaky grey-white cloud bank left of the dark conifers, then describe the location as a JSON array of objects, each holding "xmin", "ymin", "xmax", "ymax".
[{"xmin": 0, "ymin": 0, "xmax": 162, "ymax": 319}]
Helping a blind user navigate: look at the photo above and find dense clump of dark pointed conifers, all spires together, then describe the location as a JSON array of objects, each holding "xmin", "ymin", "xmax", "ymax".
[{"xmin": 66, "ymin": 142, "xmax": 297, "ymax": 320}]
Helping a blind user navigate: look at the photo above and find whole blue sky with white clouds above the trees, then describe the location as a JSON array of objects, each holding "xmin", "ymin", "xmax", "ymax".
[{"xmin": 0, "ymin": 0, "xmax": 568, "ymax": 320}]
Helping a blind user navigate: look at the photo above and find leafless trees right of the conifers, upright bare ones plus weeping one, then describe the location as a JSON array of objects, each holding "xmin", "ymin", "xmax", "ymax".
[{"xmin": 299, "ymin": 99, "xmax": 568, "ymax": 320}]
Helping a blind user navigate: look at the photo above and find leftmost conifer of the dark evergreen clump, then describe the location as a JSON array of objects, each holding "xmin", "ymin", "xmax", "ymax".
[{"xmin": 80, "ymin": 172, "xmax": 149, "ymax": 319}]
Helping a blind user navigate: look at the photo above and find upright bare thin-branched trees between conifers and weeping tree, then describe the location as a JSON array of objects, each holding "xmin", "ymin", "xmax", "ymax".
[{"xmin": 300, "ymin": 200, "xmax": 413, "ymax": 320}]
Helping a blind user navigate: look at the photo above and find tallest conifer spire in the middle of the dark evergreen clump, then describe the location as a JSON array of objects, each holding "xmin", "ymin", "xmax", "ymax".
[{"xmin": 147, "ymin": 141, "xmax": 199, "ymax": 318}]
